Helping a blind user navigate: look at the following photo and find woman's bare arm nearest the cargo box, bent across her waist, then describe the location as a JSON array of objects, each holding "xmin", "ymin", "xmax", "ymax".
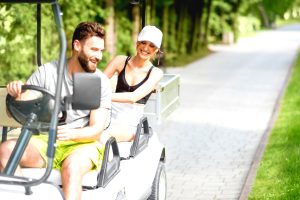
[{"xmin": 112, "ymin": 67, "xmax": 163, "ymax": 103}]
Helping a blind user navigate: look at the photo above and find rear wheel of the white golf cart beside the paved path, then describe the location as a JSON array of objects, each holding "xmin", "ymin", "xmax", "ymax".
[{"xmin": 148, "ymin": 161, "xmax": 167, "ymax": 200}]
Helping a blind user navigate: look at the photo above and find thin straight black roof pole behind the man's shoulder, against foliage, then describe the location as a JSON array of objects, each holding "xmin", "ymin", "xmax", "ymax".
[{"xmin": 36, "ymin": 3, "xmax": 42, "ymax": 66}]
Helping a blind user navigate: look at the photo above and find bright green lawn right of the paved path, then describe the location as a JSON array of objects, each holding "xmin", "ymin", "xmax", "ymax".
[{"xmin": 249, "ymin": 51, "xmax": 300, "ymax": 200}]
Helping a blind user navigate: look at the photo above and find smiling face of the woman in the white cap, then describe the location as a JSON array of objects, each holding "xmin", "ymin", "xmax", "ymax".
[{"xmin": 136, "ymin": 41, "xmax": 158, "ymax": 59}]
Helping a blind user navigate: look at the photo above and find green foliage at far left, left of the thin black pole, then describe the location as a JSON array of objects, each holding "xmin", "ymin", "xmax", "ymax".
[{"xmin": 0, "ymin": 4, "xmax": 36, "ymax": 83}]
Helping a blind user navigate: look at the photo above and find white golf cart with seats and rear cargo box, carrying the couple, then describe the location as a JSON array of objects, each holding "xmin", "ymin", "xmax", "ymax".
[{"xmin": 0, "ymin": 0, "xmax": 179, "ymax": 200}]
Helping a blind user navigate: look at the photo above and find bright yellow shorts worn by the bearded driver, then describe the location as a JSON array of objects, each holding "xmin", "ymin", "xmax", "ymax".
[{"xmin": 30, "ymin": 135, "xmax": 105, "ymax": 170}]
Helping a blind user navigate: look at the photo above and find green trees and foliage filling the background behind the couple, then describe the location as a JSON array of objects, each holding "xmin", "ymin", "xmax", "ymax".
[{"xmin": 0, "ymin": 0, "xmax": 300, "ymax": 85}]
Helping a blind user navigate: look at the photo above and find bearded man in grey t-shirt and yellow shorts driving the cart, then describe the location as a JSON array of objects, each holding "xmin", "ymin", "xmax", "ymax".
[{"xmin": 0, "ymin": 22, "xmax": 111, "ymax": 200}]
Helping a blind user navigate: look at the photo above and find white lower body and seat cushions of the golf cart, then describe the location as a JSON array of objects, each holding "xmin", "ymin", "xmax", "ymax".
[{"xmin": 0, "ymin": 122, "xmax": 165, "ymax": 200}]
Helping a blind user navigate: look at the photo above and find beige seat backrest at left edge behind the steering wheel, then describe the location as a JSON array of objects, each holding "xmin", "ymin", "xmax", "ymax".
[{"xmin": 0, "ymin": 87, "xmax": 21, "ymax": 128}]
